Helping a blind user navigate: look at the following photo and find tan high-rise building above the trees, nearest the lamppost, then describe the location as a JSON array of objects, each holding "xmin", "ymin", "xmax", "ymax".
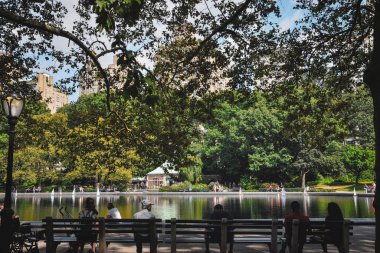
[{"xmin": 36, "ymin": 73, "xmax": 69, "ymax": 113}]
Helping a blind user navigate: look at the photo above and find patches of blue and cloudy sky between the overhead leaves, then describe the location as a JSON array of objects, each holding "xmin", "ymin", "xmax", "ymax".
[{"xmin": 37, "ymin": 0, "xmax": 302, "ymax": 102}]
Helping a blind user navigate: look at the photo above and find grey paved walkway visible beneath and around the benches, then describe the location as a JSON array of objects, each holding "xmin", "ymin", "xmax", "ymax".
[{"xmin": 35, "ymin": 226, "xmax": 375, "ymax": 253}]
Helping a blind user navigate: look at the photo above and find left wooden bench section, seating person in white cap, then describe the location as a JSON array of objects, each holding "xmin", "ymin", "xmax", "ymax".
[{"xmin": 42, "ymin": 217, "xmax": 162, "ymax": 253}]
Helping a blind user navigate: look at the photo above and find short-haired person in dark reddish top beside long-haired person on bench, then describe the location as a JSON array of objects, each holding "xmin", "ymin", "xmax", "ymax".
[{"xmin": 280, "ymin": 201, "xmax": 310, "ymax": 253}]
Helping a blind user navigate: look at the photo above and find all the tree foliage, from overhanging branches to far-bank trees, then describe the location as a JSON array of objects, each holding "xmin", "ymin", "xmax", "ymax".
[{"xmin": 0, "ymin": 0, "xmax": 380, "ymax": 192}]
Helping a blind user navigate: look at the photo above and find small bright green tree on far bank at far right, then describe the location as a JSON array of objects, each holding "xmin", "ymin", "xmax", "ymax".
[{"xmin": 342, "ymin": 145, "xmax": 375, "ymax": 184}]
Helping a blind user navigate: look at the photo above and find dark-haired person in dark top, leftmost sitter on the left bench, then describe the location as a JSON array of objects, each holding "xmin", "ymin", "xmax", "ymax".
[{"xmin": 77, "ymin": 197, "xmax": 98, "ymax": 253}]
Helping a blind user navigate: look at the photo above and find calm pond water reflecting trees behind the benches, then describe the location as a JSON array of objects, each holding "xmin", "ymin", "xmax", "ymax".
[{"xmin": 12, "ymin": 193, "xmax": 375, "ymax": 221}]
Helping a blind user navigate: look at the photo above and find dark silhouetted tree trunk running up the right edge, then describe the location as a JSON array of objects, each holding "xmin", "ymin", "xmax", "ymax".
[{"xmin": 364, "ymin": 0, "xmax": 380, "ymax": 252}]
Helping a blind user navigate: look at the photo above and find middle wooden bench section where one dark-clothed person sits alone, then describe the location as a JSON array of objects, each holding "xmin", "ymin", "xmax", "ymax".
[{"xmin": 164, "ymin": 218, "xmax": 283, "ymax": 253}]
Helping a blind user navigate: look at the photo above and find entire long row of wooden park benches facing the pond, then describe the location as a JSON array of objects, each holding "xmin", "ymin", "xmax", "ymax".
[{"xmin": 43, "ymin": 218, "xmax": 375, "ymax": 253}]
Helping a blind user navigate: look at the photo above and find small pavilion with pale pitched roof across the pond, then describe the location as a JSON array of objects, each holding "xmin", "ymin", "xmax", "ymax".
[{"xmin": 146, "ymin": 162, "xmax": 179, "ymax": 188}]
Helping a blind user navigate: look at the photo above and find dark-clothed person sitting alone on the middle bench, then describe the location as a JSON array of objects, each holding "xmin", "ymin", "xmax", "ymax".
[{"xmin": 205, "ymin": 204, "xmax": 234, "ymax": 253}]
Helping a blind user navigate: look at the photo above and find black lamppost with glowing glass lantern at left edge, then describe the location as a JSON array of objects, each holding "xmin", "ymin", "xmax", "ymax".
[{"xmin": 0, "ymin": 93, "xmax": 25, "ymax": 252}]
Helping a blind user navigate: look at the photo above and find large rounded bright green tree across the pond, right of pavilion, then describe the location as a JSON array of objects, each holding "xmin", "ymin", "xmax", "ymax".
[{"xmin": 201, "ymin": 92, "xmax": 289, "ymax": 183}]
